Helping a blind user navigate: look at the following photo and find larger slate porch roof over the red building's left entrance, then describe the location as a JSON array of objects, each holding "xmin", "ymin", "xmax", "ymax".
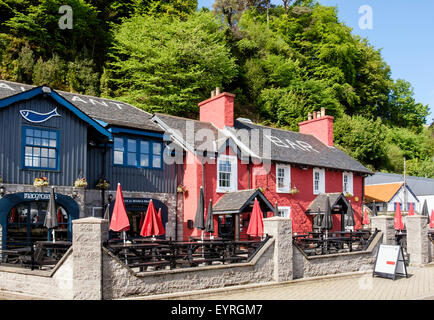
[{"xmin": 212, "ymin": 189, "xmax": 274, "ymax": 214}]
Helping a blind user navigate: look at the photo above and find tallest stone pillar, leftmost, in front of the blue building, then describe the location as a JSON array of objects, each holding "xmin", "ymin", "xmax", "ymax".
[{"xmin": 72, "ymin": 217, "xmax": 108, "ymax": 300}]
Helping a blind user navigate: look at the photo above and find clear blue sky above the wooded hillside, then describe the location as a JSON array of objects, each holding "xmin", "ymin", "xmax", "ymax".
[{"xmin": 199, "ymin": 0, "xmax": 434, "ymax": 124}]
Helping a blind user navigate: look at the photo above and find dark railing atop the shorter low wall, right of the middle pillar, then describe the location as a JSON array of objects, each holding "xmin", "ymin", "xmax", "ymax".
[{"xmin": 293, "ymin": 230, "xmax": 378, "ymax": 256}]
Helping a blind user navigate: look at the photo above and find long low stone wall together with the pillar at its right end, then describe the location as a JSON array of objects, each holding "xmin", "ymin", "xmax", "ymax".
[{"xmin": 103, "ymin": 217, "xmax": 292, "ymax": 299}]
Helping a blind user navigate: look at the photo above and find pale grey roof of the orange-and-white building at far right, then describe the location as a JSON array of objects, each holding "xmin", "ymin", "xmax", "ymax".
[{"xmin": 365, "ymin": 172, "xmax": 434, "ymax": 196}]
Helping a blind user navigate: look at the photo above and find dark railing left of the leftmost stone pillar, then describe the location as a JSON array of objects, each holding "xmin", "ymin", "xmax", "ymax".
[{"xmin": 0, "ymin": 241, "xmax": 72, "ymax": 270}]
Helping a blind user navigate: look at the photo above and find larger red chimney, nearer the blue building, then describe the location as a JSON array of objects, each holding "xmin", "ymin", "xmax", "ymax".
[{"xmin": 199, "ymin": 88, "xmax": 235, "ymax": 129}]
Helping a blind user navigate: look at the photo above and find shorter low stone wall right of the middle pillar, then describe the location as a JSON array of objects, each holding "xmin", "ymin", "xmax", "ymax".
[{"xmin": 293, "ymin": 232, "xmax": 383, "ymax": 279}]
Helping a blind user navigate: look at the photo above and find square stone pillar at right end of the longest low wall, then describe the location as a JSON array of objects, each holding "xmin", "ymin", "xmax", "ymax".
[{"xmin": 264, "ymin": 217, "xmax": 293, "ymax": 282}]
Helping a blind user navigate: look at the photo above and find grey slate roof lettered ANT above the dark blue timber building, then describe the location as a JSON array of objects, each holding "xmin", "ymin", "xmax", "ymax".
[{"xmin": 0, "ymin": 80, "xmax": 163, "ymax": 132}]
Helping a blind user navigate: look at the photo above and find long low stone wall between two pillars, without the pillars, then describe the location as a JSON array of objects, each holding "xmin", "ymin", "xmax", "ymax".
[{"xmin": 103, "ymin": 239, "xmax": 274, "ymax": 299}]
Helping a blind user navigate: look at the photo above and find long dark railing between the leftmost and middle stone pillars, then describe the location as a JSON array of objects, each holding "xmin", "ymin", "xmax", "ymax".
[{"xmin": 104, "ymin": 236, "xmax": 270, "ymax": 272}]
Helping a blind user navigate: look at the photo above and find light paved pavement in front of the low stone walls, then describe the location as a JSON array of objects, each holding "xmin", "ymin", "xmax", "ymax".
[{"xmin": 165, "ymin": 264, "xmax": 434, "ymax": 300}]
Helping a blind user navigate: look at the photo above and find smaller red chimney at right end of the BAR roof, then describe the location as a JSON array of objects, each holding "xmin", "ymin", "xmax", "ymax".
[{"xmin": 298, "ymin": 108, "xmax": 334, "ymax": 147}]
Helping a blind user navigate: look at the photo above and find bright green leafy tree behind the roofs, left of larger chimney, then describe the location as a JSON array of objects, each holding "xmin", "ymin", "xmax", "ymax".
[{"xmin": 104, "ymin": 12, "xmax": 237, "ymax": 115}]
